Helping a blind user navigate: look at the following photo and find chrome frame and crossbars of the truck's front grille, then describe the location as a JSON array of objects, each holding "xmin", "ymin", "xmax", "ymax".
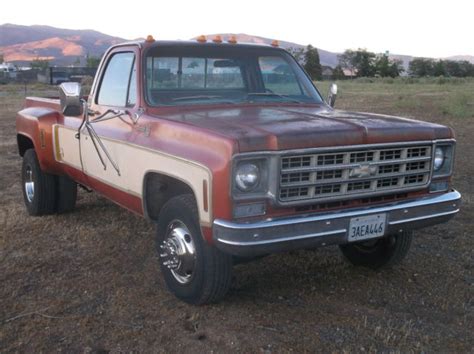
[{"xmin": 275, "ymin": 143, "xmax": 434, "ymax": 205}]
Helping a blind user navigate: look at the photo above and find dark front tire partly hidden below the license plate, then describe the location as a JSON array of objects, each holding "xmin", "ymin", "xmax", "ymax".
[{"xmin": 339, "ymin": 231, "xmax": 413, "ymax": 269}]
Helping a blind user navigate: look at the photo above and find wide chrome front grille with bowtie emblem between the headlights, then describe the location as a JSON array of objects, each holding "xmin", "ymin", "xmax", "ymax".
[{"xmin": 278, "ymin": 145, "xmax": 432, "ymax": 203}]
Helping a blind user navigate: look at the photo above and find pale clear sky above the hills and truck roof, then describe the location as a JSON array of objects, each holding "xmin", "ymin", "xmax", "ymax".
[{"xmin": 0, "ymin": 0, "xmax": 474, "ymax": 58}]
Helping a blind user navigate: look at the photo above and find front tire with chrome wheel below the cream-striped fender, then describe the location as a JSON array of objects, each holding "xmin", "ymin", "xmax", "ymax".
[{"xmin": 156, "ymin": 194, "xmax": 232, "ymax": 305}]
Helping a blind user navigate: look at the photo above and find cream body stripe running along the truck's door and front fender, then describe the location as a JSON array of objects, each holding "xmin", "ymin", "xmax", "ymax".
[{"xmin": 54, "ymin": 125, "xmax": 212, "ymax": 226}]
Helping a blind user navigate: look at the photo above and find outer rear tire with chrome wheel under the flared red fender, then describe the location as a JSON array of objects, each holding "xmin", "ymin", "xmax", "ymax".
[{"xmin": 21, "ymin": 149, "xmax": 57, "ymax": 216}]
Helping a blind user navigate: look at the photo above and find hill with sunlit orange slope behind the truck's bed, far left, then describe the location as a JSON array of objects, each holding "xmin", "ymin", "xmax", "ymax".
[{"xmin": 0, "ymin": 24, "xmax": 125, "ymax": 65}]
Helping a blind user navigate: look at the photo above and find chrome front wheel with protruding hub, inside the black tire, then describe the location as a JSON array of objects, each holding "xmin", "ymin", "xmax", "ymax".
[{"xmin": 160, "ymin": 220, "xmax": 196, "ymax": 284}]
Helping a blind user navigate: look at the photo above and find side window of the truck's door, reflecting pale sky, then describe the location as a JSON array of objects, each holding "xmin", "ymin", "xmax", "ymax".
[{"xmin": 97, "ymin": 52, "xmax": 136, "ymax": 107}]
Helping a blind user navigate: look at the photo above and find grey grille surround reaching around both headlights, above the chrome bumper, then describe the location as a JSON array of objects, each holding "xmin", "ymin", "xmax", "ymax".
[{"xmin": 230, "ymin": 138, "xmax": 456, "ymax": 208}]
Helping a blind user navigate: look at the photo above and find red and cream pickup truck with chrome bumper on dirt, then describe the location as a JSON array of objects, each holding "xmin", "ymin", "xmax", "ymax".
[{"xmin": 16, "ymin": 36, "xmax": 461, "ymax": 304}]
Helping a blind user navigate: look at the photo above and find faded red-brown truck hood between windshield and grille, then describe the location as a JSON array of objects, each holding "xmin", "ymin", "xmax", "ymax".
[{"xmin": 154, "ymin": 105, "xmax": 453, "ymax": 152}]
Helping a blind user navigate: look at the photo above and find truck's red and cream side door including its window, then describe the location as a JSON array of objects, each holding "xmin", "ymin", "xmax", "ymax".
[{"xmin": 80, "ymin": 47, "xmax": 138, "ymax": 205}]
